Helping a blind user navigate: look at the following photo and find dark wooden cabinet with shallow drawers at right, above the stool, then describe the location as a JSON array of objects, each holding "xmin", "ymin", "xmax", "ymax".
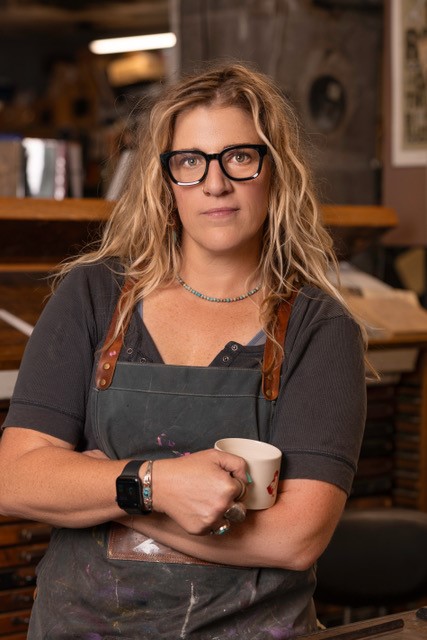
[{"xmin": 347, "ymin": 334, "xmax": 427, "ymax": 511}]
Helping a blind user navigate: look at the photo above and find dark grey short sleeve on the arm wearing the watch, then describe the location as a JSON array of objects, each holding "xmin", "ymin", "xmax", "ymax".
[{"xmin": 3, "ymin": 265, "xmax": 119, "ymax": 445}]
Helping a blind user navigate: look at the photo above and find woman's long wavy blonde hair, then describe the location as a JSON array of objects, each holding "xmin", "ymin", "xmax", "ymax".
[{"xmin": 57, "ymin": 62, "xmax": 362, "ymax": 348}]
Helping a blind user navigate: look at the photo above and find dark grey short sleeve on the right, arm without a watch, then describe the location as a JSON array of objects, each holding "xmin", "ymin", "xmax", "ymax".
[{"xmin": 272, "ymin": 290, "xmax": 366, "ymax": 494}]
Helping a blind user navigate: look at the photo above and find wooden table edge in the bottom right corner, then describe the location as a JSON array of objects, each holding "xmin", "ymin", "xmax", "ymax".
[{"xmin": 300, "ymin": 607, "xmax": 427, "ymax": 640}]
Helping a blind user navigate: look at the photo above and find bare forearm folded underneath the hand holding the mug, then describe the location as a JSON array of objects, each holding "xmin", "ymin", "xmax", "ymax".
[{"xmin": 121, "ymin": 476, "xmax": 346, "ymax": 571}]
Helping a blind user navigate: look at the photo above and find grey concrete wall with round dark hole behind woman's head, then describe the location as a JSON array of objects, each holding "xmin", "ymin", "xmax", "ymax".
[{"xmin": 174, "ymin": 0, "xmax": 383, "ymax": 204}]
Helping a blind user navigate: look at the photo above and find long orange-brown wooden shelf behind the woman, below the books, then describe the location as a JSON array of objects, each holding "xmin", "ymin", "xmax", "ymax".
[{"xmin": 0, "ymin": 197, "xmax": 397, "ymax": 273}]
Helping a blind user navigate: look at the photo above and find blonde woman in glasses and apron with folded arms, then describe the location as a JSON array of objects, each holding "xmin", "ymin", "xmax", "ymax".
[{"xmin": 0, "ymin": 64, "xmax": 365, "ymax": 640}]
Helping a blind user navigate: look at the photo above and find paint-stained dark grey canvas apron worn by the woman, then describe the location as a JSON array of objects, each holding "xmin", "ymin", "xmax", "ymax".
[{"xmin": 28, "ymin": 292, "xmax": 316, "ymax": 640}]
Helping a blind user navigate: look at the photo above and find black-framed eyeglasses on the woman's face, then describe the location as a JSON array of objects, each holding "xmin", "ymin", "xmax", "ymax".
[{"xmin": 160, "ymin": 144, "xmax": 267, "ymax": 187}]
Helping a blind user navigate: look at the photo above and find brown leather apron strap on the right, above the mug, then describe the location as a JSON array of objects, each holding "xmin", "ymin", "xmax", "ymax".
[{"xmin": 262, "ymin": 291, "xmax": 298, "ymax": 400}]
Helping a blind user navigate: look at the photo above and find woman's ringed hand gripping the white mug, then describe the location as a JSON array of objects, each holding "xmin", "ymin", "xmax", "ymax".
[{"xmin": 153, "ymin": 449, "xmax": 247, "ymax": 535}]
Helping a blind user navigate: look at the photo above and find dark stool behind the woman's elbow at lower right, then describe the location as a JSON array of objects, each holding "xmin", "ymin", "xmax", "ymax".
[{"xmin": 315, "ymin": 508, "xmax": 427, "ymax": 622}]
